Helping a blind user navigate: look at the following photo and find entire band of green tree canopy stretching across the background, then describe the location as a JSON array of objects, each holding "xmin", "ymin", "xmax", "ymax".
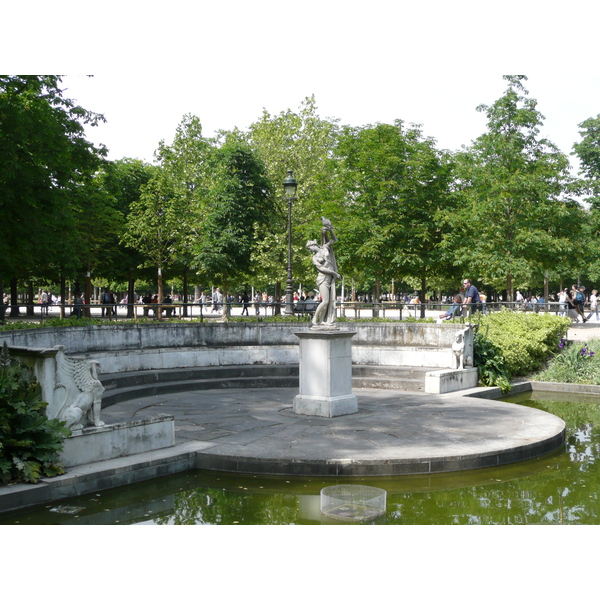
[{"xmin": 0, "ymin": 75, "xmax": 600, "ymax": 308}]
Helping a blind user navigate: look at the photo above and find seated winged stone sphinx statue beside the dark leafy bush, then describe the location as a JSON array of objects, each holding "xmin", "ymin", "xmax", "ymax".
[{"xmin": 51, "ymin": 346, "xmax": 104, "ymax": 431}]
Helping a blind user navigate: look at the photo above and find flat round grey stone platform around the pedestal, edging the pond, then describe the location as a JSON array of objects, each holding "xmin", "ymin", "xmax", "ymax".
[{"xmin": 102, "ymin": 388, "xmax": 565, "ymax": 477}]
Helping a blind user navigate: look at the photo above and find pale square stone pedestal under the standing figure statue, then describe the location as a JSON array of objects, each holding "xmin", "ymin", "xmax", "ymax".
[{"xmin": 294, "ymin": 329, "xmax": 358, "ymax": 417}]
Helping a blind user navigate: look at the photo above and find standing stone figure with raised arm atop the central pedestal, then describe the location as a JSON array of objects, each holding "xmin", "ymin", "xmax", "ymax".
[{"xmin": 306, "ymin": 217, "xmax": 340, "ymax": 329}]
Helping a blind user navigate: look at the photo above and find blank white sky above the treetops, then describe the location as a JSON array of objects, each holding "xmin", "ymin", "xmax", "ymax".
[{"xmin": 7, "ymin": 0, "xmax": 600, "ymax": 173}]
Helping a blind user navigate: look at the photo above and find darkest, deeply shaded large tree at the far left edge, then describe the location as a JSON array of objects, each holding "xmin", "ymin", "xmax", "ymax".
[{"xmin": 0, "ymin": 75, "xmax": 106, "ymax": 310}]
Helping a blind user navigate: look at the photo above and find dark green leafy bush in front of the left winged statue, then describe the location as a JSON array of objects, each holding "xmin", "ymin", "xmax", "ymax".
[{"xmin": 0, "ymin": 342, "xmax": 70, "ymax": 483}]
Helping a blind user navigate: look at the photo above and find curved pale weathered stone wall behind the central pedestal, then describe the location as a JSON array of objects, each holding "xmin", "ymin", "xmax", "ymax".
[{"xmin": 0, "ymin": 322, "xmax": 463, "ymax": 373}]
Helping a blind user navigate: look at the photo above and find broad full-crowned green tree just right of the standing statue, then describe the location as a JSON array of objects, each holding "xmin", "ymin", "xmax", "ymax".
[{"xmin": 325, "ymin": 120, "xmax": 452, "ymax": 300}]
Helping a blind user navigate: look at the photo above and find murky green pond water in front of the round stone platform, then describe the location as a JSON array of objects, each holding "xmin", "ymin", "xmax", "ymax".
[{"xmin": 0, "ymin": 392, "xmax": 600, "ymax": 525}]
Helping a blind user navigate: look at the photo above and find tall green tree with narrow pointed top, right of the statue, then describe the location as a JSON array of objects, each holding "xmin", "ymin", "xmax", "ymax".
[{"xmin": 445, "ymin": 75, "xmax": 581, "ymax": 300}]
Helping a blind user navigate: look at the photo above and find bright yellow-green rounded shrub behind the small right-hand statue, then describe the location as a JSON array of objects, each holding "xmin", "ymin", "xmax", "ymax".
[{"xmin": 479, "ymin": 310, "xmax": 570, "ymax": 377}]
